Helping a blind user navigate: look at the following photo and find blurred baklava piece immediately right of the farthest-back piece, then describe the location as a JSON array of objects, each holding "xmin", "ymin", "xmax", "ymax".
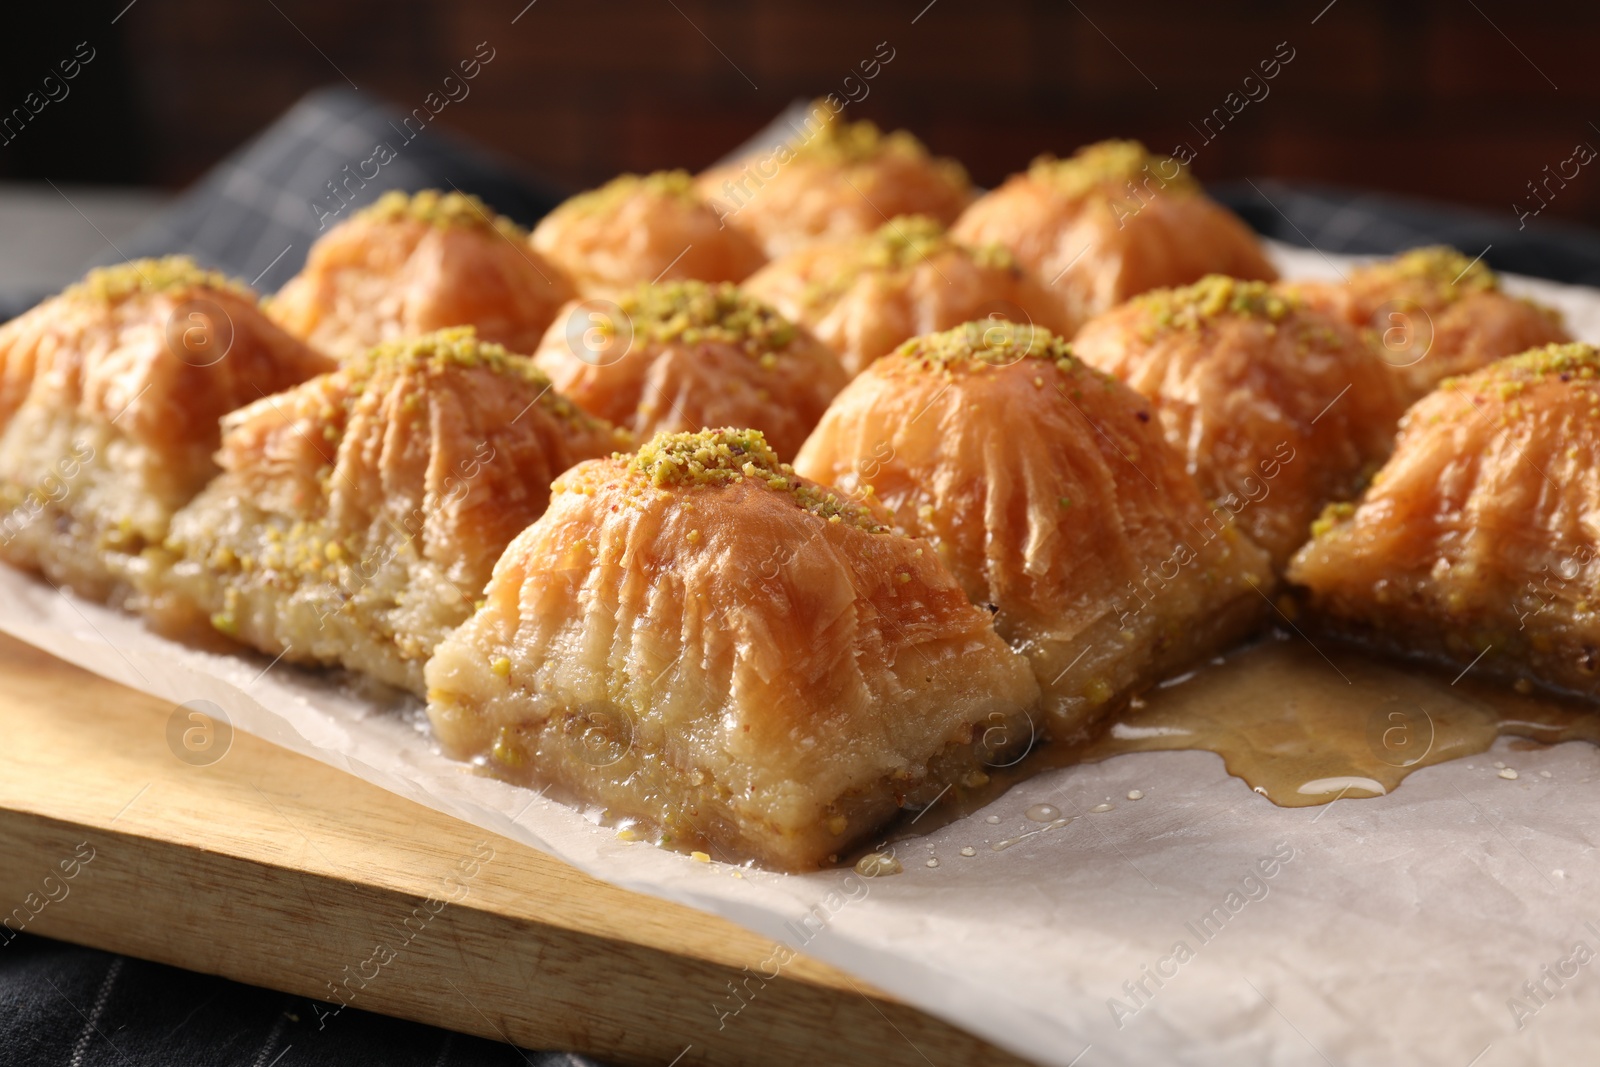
[{"xmin": 950, "ymin": 141, "xmax": 1277, "ymax": 326}]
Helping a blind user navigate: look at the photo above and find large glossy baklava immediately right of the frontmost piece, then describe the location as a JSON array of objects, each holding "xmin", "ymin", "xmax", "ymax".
[{"xmin": 795, "ymin": 322, "xmax": 1272, "ymax": 739}]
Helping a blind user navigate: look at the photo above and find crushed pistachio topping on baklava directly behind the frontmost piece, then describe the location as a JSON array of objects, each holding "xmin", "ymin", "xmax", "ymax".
[{"xmin": 619, "ymin": 282, "xmax": 798, "ymax": 357}]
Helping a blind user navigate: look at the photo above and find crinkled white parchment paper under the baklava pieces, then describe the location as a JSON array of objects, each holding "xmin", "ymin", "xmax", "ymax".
[{"xmin": 0, "ymin": 241, "xmax": 1600, "ymax": 1067}]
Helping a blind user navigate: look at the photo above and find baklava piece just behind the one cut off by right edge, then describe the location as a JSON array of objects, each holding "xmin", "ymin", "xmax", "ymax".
[{"xmin": 1285, "ymin": 248, "xmax": 1571, "ymax": 402}]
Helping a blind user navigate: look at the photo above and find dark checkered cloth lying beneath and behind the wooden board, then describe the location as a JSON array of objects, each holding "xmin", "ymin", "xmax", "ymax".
[{"xmin": 9, "ymin": 88, "xmax": 1600, "ymax": 1067}]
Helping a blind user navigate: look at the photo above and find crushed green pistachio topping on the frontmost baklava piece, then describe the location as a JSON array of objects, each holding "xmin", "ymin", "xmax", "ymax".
[{"xmin": 618, "ymin": 427, "xmax": 888, "ymax": 533}]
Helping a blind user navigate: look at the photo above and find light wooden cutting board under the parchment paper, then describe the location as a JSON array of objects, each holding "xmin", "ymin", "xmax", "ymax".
[{"xmin": 0, "ymin": 637, "xmax": 1021, "ymax": 1067}]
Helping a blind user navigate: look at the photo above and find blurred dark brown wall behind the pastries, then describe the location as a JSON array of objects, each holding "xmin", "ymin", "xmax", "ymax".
[{"xmin": 0, "ymin": 0, "xmax": 1600, "ymax": 226}]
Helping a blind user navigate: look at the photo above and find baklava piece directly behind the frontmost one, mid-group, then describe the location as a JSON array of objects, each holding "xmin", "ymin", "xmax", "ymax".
[{"xmin": 534, "ymin": 282, "xmax": 848, "ymax": 458}]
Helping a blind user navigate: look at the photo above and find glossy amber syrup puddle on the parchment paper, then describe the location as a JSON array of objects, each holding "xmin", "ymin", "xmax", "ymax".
[{"xmin": 888, "ymin": 633, "xmax": 1600, "ymax": 845}]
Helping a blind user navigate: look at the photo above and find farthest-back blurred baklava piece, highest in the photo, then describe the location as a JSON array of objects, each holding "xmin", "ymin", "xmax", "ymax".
[{"xmin": 698, "ymin": 101, "xmax": 973, "ymax": 259}]
